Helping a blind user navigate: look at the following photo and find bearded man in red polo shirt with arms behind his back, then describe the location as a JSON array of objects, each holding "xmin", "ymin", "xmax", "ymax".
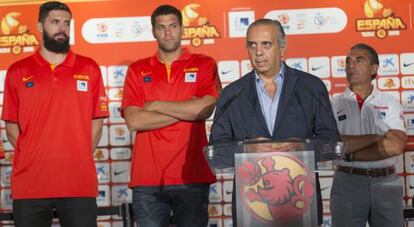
[{"xmin": 2, "ymin": 2, "xmax": 108, "ymax": 227}]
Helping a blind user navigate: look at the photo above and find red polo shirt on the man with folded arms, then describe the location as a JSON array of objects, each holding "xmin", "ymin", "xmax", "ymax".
[{"xmin": 122, "ymin": 49, "xmax": 220, "ymax": 187}]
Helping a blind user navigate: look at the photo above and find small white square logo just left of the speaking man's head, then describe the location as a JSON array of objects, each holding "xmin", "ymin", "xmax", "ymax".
[{"xmin": 229, "ymin": 10, "xmax": 255, "ymax": 38}]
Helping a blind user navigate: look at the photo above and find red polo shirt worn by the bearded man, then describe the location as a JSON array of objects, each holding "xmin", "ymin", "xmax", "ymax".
[{"xmin": 2, "ymin": 51, "xmax": 108, "ymax": 199}]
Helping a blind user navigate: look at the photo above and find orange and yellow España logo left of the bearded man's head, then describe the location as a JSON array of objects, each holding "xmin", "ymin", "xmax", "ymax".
[{"xmin": 0, "ymin": 12, "xmax": 39, "ymax": 55}]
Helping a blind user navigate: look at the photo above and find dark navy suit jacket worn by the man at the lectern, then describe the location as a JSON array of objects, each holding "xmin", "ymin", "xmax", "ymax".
[{"xmin": 210, "ymin": 65, "xmax": 339, "ymax": 144}]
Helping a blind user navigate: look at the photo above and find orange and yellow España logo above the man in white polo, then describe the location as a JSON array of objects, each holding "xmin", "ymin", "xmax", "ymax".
[{"xmin": 355, "ymin": 0, "xmax": 407, "ymax": 39}]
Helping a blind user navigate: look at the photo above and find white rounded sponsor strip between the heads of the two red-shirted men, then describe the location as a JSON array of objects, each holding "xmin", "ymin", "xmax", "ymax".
[{"xmin": 82, "ymin": 16, "xmax": 155, "ymax": 43}]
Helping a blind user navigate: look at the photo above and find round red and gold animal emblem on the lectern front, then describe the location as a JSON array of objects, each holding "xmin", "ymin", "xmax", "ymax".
[{"xmin": 236, "ymin": 153, "xmax": 315, "ymax": 223}]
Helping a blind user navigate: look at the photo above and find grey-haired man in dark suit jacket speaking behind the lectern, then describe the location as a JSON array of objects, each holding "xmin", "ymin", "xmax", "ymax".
[{"xmin": 210, "ymin": 19, "xmax": 338, "ymax": 226}]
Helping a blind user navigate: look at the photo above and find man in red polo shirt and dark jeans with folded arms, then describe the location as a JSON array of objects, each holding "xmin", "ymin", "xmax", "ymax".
[{"xmin": 122, "ymin": 5, "xmax": 221, "ymax": 227}]
